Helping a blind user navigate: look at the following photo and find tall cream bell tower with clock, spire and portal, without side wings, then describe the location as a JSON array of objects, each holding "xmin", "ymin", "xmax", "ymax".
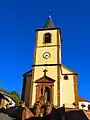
[{"xmin": 32, "ymin": 16, "xmax": 61, "ymax": 106}]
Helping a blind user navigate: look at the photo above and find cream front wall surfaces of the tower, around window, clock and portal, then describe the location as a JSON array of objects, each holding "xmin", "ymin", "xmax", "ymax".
[{"xmin": 32, "ymin": 30, "xmax": 61, "ymax": 105}]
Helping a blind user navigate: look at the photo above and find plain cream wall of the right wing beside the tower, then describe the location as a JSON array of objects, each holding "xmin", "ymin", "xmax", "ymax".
[{"xmin": 61, "ymin": 68, "xmax": 75, "ymax": 108}]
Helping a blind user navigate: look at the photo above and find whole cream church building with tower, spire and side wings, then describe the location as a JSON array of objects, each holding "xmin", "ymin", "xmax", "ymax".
[{"xmin": 22, "ymin": 16, "xmax": 79, "ymax": 108}]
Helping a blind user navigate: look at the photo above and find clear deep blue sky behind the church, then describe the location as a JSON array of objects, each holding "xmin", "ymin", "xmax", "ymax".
[{"xmin": 0, "ymin": 0, "xmax": 90, "ymax": 100}]
